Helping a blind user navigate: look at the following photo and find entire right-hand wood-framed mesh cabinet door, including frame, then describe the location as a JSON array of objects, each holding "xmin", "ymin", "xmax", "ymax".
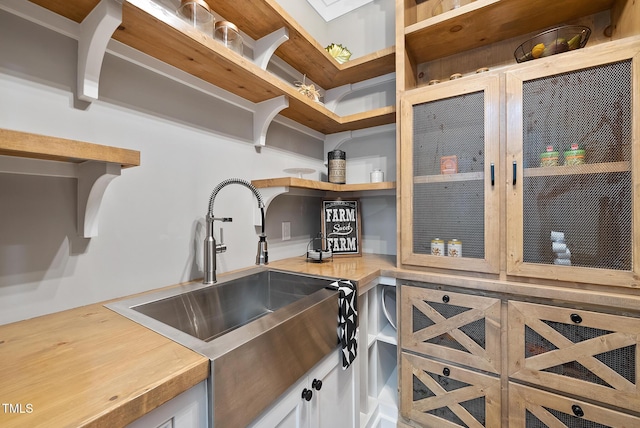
[{"xmin": 506, "ymin": 39, "xmax": 640, "ymax": 287}]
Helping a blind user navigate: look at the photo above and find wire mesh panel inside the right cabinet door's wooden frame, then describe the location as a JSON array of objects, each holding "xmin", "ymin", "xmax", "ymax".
[{"xmin": 523, "ymin": 60, "xmax": 633, "ymax": 270}]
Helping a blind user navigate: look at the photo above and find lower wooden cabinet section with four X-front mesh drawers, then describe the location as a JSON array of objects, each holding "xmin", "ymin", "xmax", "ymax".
[{"xmin": 399, "ymin": 280, "xmax": 640, "ymax": 428}]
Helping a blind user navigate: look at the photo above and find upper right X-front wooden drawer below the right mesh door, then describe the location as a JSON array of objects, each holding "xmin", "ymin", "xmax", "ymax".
[{"xmin": 508, "ymin": 302, "xmax": 640, "ymax": 411}]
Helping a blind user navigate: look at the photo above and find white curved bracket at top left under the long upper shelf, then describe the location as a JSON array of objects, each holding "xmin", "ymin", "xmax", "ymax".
[{"xmin": 77, "ymin": 0, "xmax": 122, "ymax": 102}]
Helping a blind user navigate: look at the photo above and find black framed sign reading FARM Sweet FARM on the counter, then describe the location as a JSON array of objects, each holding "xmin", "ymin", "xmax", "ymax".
[{"xmin": 322, "ymin": 199, "xmax": 362, "ymax": 256}]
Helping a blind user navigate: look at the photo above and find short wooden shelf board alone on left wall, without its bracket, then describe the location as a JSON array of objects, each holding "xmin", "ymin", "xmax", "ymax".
[{"xmin": 0, "ymin": 129, "xmax": 140, "ymax": 168}]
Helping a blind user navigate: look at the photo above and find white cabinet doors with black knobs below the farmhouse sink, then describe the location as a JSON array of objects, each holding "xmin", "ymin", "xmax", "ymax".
[{"xmin": 250, "ymin": 349, "xmax": 360, "ymax": 428}]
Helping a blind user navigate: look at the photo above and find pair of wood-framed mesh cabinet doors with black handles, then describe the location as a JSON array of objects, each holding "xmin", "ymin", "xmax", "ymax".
[{"xmin": 400, "ymin": 37, "xmax": 640, "ymax": 288}]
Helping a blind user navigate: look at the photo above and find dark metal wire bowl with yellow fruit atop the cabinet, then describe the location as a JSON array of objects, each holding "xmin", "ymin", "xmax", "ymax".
[{"xmin": 513, "ymin": 25, "xmax": 591, "ymax": 62}]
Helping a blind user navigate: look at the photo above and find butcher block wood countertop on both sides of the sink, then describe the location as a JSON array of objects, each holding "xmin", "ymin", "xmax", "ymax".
[{"xmin": 0, "ymin": 255, "xmax": 395, "ymax": 428}]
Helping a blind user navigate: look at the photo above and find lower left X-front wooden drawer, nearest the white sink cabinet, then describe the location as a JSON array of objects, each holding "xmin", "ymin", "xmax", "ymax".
[{"xmin": 400, "ymin": 352, "xmax": 501, "ymax": 428}]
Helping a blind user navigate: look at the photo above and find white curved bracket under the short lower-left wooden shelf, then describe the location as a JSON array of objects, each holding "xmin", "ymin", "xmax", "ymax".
[{"xmin": 77, "ymin": 161, "xmax": 121, "ymax": 238}]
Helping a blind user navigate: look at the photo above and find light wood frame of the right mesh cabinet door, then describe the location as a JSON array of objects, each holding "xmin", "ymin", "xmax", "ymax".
[{"xmin": 505, "ymin": 37, "xmax": 640, "ymax": 288}]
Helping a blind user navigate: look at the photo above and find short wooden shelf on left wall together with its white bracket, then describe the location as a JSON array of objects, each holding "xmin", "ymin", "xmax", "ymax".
[{"xmin": 0, "ymin": 129, "xmax": 140, "ymax": 238}]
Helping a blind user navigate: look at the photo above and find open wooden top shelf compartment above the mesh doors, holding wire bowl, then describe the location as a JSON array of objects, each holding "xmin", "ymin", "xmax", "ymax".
[{"xmin": 396, "ymin": 0, "xmax": 640, "ymax": 91}]
